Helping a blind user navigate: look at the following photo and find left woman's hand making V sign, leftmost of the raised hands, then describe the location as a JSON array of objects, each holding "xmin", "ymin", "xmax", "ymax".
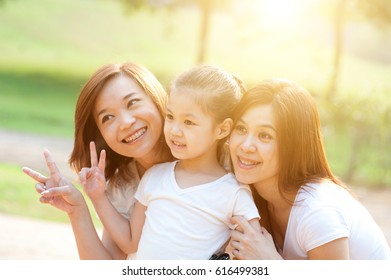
[{"xmin": 22, "ymin": 150, "xmax": 85, "ymax": 214}]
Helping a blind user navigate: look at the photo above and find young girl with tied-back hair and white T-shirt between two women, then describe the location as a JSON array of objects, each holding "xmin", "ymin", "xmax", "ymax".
[{"xmin": 87, "ymin": 66, "xmax": 260, "ymax": 260}]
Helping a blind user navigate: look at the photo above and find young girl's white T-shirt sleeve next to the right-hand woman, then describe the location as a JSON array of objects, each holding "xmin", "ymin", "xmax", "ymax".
[{"xmin": 233, "ymin": 186, "xmax": 260, "ymax": 221}]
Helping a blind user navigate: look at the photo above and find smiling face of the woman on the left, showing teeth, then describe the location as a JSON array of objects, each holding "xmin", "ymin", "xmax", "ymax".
[{"xmin": 94, "ymin": 75, "xmax": 163, "ymax": 160}]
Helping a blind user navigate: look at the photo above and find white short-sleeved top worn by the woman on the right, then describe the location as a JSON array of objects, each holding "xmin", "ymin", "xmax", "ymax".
[{"xmin": 280, "ymin": 181, "xmax": 391, "ymax": 260}]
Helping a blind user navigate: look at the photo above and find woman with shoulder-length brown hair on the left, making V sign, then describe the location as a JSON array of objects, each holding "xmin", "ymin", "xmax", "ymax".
[{"xmin": 23, "ymin": 63, "xmax": 173, "ymax": 259}]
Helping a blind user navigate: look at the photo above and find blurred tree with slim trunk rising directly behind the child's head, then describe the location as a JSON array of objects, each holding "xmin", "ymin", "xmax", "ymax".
[{"xmin": 119, "ymin": 0, "xmax": 231, "ymax": 64}]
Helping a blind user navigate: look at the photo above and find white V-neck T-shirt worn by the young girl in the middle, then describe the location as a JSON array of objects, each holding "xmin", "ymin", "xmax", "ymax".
[{"xmin": 135, "ymin": 161, "xmax": 259, "ymax": 260}]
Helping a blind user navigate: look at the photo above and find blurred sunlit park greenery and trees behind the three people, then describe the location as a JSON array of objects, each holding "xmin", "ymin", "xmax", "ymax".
[{"xmin": 0, "ymin": 0, "xmax": 391, "ymax": 258}]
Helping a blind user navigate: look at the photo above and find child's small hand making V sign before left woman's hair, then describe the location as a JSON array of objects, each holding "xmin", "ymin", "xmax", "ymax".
[{"xmin": 79, "ymin": 142, "xmax": 106, "ymax": 201}]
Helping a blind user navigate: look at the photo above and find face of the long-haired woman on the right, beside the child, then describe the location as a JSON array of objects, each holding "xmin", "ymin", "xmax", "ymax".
[{"xmin": 229, "ymin": 105, "xmax": 279, "ymax": 188}]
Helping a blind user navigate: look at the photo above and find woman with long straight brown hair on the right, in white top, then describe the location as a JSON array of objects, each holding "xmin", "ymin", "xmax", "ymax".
[{"xmin": 229, "ymin": 79, "xmax": 391, "ymax": 260}]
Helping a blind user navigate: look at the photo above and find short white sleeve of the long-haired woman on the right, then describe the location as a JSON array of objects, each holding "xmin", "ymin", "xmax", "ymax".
[{"xmin": 296, "ymin": 206, "xmax": 349, "ymax": 252}]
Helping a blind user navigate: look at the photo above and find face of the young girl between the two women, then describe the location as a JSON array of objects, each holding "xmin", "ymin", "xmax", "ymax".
[{"xmin": 164, "ymin": 93, "xmax": 222, "ymax": 159}]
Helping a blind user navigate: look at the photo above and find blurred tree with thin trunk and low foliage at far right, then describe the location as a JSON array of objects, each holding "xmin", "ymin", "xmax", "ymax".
[{"xmin": 325, "ymin": 0, "xmax": 391, "ymax": 186}]
